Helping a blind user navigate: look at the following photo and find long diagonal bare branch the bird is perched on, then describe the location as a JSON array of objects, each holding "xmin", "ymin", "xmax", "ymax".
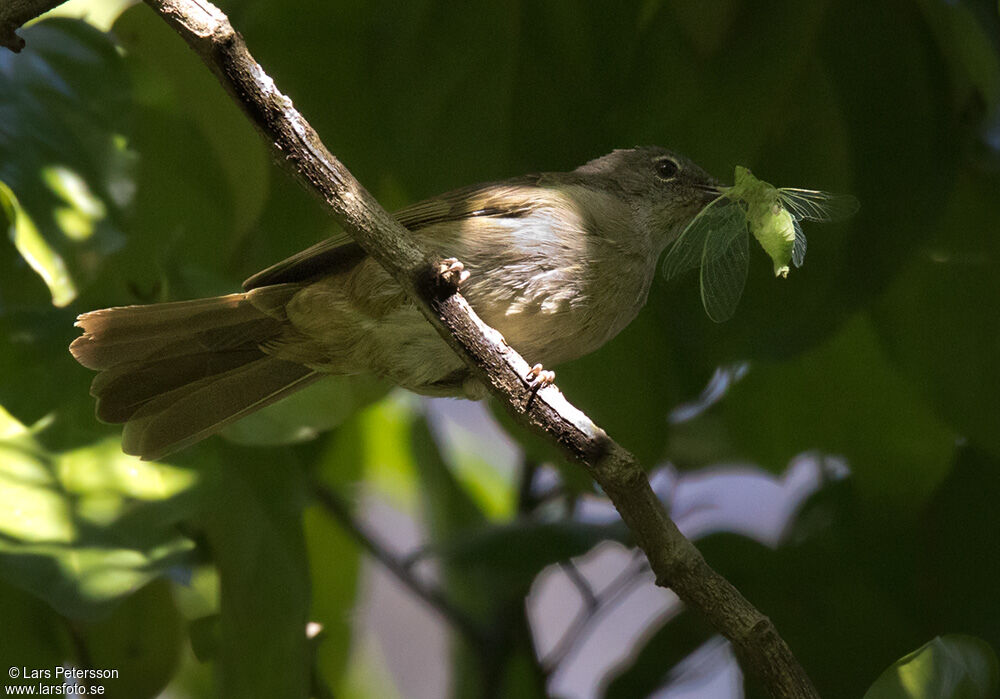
[{"xmin": 0, "ymin": 0, "xmax": 818, "ymax": 698}]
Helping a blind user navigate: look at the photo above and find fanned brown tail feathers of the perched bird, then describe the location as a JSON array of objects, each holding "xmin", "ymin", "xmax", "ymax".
[{"xmin": 69, "ymin": 284, "xmax": 320, "ymax": 459}]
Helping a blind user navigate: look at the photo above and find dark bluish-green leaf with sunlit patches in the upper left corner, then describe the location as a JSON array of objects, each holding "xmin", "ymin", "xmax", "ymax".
[{"xmin": 0, "ymin": 19, "xmax": 132, "ymax": 306}]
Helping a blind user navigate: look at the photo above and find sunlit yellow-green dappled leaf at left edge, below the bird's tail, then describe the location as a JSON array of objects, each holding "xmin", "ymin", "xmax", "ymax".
[{"xmin": 0, "ymin": 412, "xmax": 197, "ymax": 619}]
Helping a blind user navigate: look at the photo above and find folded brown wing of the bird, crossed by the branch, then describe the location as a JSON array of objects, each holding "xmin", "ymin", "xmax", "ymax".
[{"xmin": 243, "ymin": 175, "xmax": 542, "ymax": 291}]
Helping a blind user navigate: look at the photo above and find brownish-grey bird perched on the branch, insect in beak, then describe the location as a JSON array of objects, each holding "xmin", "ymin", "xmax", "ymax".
[{"xmin": 69, "ymin": 146, "xmax": 719, "ymax": 460}]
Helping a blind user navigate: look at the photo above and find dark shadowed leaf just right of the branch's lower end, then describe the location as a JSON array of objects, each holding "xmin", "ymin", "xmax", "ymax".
[{"xmin": 696, "ymin": 520, "xmax": 929, "ymax": 697}]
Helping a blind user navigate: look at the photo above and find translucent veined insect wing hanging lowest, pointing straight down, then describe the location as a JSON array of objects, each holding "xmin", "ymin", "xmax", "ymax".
[{"xmin": 701, "ymin": 212, "xmax": 750, "ymax": 323}]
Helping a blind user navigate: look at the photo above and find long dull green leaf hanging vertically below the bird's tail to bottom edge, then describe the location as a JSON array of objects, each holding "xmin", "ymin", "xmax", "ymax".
[{"xmin": 204, "ymin": 444, "xmax": 309, "ymax": 699}]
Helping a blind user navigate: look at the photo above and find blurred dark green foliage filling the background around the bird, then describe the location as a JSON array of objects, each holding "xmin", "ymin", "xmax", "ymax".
[{"xmin": 0, "ymin": 0, "xmax": 1000, "ymax": 699}]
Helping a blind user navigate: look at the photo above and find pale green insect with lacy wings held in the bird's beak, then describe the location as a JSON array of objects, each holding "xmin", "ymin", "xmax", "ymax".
[{"xmin": 663, "ymin": 166, "xmax": 859, "ymax": 323}]
